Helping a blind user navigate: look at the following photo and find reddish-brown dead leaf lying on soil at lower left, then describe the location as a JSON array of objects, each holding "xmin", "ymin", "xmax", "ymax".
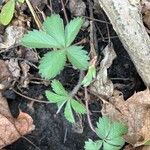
[{"xmin": 0, "ymin": 93, "xmax": 35, "ymax": 149}]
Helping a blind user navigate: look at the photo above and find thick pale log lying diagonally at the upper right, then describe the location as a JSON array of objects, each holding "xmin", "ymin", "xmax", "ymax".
[{"xmin": 98, "ymin": 0, "xmax": 150, "ymax": 87}]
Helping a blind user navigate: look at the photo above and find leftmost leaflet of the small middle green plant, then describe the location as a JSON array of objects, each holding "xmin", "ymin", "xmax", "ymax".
[{"xmin": 45, "ymin": 91, "xmax": 68, "ymax": 103}]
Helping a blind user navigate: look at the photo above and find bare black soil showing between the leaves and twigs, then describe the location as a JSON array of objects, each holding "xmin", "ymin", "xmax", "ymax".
[{"xmin": 1, "ymin": 0, "xmax": 144, "ymax": 150}]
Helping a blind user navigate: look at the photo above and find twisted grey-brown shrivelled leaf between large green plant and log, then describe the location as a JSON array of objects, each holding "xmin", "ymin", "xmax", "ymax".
[{"xmin": 90, "ymin": 43, "xmax": 116, "ymax": 98}]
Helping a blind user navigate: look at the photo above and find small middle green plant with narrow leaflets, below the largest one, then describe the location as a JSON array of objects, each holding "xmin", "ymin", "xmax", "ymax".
[{"xmin": 45, "ymin": 80, "xmax": 86, "ymax": 123}]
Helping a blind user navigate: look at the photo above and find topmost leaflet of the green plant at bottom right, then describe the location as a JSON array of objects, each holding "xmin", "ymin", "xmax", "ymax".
[{"xmin": 96, "ymin": 117, "xmax": 111, "ymax": 139}]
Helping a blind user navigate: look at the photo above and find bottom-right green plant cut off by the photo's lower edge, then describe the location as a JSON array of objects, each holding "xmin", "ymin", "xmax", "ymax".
[{"xmin": 84, "ymin": 117, "xmax": 128, "ymax": 150}]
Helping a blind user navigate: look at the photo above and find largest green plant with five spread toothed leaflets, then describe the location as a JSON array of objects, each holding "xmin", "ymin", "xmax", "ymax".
[{"xmin": 22, "ymin": 14, "xmax": 89, "ymax": 79}]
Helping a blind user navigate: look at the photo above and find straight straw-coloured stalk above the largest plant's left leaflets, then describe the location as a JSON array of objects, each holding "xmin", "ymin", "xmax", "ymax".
[{"xmin": 26, "ymin": 0, "xmax": 42, "ymax": 29}]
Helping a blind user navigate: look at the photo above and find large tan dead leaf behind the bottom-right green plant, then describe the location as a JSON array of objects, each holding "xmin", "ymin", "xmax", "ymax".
[{"xmin": 102, "ymin": 89, "xmax": 150, "ymax": 147}]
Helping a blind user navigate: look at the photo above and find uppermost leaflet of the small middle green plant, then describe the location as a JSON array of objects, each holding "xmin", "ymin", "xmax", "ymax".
[{"xmin": 51, "ymin": 80, "xmax": 68, "ymax": 96}]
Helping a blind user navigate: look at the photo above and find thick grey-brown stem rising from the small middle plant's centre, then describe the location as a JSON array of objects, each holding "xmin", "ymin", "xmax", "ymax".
[{"xmin": 70, "ymin": 70, "xmax": 84, "ymax": 97}]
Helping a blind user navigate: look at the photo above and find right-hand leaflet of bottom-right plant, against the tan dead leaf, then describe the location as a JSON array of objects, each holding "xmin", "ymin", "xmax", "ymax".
[{"xmin": 107, "ymin": 122, "xmax": 128, "ymax": 139}]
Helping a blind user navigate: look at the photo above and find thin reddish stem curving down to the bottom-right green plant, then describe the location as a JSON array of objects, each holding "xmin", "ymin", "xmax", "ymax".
[{"xmin": 84, "ymin": 87, "xmax": 96, "ymax": 133}]
